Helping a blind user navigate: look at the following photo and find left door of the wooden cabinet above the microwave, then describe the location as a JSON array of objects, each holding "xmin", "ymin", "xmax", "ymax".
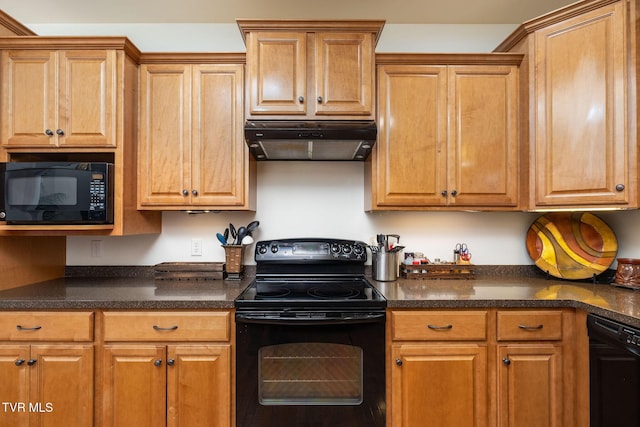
[{"xmin": 2, "ymin": 50, "xmax": 58, "ymax": 147}]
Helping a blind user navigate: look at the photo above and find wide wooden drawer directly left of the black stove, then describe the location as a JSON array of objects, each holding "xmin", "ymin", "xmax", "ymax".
[{"xmin": 103, "ymin": 311, "xmax": 231, "ymax": 341}]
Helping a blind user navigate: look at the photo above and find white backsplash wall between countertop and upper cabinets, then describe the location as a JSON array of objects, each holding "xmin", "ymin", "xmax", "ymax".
[{"xmin": 67, "ymin": 162, "xmax": 640, "ymax": 265}]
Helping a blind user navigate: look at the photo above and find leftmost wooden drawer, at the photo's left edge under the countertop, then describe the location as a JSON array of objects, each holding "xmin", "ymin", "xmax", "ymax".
[{"xmin": 0, "ymin": 311, "xmax": 93, "ymax": 341}]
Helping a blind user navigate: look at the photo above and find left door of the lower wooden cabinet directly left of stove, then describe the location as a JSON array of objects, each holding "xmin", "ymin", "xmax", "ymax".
[{"xmin": 102, "ymin": 344, "xmax": 166, "ymax": 427}]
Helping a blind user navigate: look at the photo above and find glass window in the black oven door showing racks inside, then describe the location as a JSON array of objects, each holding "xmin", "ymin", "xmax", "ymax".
[{"xmin": 258, "ymin": 342, "xmax": 363, "ymax": 405}]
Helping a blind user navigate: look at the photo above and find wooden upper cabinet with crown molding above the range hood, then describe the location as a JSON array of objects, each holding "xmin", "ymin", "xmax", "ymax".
[{"xmin": 238, "ymin": 20, "xmax": 384, "ymax": 119}]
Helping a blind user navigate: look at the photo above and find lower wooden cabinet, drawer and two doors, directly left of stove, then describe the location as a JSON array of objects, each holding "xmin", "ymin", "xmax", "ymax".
[{"xmin": 102, "ymin": 311, "xmax": 235, "ymax": 427}]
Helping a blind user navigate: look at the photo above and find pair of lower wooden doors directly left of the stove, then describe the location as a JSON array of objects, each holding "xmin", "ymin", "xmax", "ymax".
[{"xmin": 103, "ymin": 344, "xmax": 231, "ymax": 427}]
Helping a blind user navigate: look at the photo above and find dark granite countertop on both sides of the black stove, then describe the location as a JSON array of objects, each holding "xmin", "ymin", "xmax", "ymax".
[{"xmin": 0, "ymin": 275, "xmax": 640, "ymax": 327}]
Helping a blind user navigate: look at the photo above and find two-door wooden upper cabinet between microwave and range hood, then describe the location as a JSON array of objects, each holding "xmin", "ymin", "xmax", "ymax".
[{"xmin": 138, "ymin": 56, "xmax": 255, "ymax": 210}]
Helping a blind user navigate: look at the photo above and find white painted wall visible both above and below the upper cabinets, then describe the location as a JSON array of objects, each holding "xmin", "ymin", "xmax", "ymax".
[{"xmin": 26, "ymin": 23, "xmax": 640, "ymax": 265}]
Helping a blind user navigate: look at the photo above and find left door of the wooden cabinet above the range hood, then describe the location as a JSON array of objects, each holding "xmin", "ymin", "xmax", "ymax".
[{"xmin": 246, "ymin": 31, "xmax": 308, "ymax": 116}]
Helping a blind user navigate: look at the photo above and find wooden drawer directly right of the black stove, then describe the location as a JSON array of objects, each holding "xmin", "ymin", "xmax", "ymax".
[{"xmin": 391, "ymin": 311, "xmax": 487, "ymax": 341}]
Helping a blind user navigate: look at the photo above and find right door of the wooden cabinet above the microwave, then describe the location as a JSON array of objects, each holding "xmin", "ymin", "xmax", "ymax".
[{"xmin": 55, "ymin": 50, "xmax": 117, "ymax": 147}]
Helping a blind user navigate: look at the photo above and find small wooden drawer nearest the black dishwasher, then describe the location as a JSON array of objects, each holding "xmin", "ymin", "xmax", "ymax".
[{"xmin": 497, "ymin": 310, "xmax": 562, "ymax": 341}]
